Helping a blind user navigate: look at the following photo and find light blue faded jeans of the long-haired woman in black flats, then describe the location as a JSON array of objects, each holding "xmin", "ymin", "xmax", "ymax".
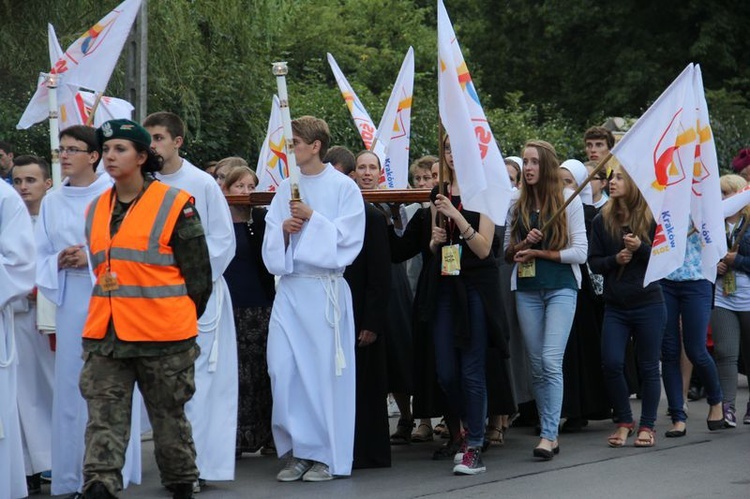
[{"xmin": 516, "ymin": 289, "xmax": 578, "ymax": 441}]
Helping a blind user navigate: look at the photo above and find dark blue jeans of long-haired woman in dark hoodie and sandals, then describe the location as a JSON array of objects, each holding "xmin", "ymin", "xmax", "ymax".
[{"xmin": 602, "ymin": 303, "xmax": 667, "ymax": 429}]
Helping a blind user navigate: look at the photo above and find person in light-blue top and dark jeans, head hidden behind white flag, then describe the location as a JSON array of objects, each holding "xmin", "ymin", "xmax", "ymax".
[{"xmin": 661, "ymin": 228, "xmax": 727, "ymax": 437}]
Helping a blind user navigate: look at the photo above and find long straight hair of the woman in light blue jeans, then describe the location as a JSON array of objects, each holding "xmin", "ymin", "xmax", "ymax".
[{"xmin": 511, "ymin": 140, "xmax": 568, "ymax": 250}]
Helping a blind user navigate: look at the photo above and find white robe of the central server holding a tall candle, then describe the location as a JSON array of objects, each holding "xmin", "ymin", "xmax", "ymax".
[{"xmin": 263, "ymin": 165, "xmax": 365, "ymax": 475}]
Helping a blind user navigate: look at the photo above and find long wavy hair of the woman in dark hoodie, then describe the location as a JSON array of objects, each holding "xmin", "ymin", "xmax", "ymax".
[{"xmin": 602, "ymin": 163, "xmax": 654, "ymax": 244}]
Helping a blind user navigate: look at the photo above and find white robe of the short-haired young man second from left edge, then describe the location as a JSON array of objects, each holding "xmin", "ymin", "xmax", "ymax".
[{"xmin": 13, "ymin": 217, "xmax": 55, "ymax": 475}]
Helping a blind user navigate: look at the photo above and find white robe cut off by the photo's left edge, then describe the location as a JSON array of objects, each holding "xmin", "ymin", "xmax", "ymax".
[{"xmin": 0, "ymin": 182, "xmax": 35, "ymax": 499}]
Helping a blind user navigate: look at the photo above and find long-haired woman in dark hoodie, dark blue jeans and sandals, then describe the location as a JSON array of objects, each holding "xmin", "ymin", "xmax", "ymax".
[{"xmin": 589, "ymin": 165, "xmax": 667, "ymax": 447}]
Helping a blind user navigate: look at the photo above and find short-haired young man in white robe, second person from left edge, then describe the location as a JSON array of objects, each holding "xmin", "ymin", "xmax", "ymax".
[{"xmin": 11, "ymin": 156, "xmax": 55, "ymax": 484}]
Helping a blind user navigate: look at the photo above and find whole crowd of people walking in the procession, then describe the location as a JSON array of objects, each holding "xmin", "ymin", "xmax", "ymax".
[{"xmin": 0, "ymin": 118, "xmax": 750, "ymax": 499}]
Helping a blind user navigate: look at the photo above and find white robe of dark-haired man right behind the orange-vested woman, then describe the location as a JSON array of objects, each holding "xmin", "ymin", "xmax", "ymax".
[{"xmin": 157, "ymin": 159, "xmax": 238, "ymax": 481}]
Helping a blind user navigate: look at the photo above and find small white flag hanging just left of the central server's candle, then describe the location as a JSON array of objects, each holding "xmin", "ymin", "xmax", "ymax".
[{"xmin": 255, "ymin": 95, "xmax": 289, "ymax": 191}]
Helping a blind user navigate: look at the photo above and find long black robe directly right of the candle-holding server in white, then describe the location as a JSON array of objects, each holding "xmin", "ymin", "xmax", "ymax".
[{"xmin": 344, "ymin": 204, "xmax": 391, "ymax": 469}]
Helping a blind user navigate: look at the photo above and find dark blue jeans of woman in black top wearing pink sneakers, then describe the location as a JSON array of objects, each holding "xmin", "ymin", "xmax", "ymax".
[{"xmin": 433, "ymin": 277, "xmax": 488, "ymax": 447}]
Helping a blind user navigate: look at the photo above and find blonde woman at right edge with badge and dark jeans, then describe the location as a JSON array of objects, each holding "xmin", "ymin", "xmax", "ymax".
[{"xmin": 711, "ymin": 175, "xmax": 750, "ymax": 428}]
